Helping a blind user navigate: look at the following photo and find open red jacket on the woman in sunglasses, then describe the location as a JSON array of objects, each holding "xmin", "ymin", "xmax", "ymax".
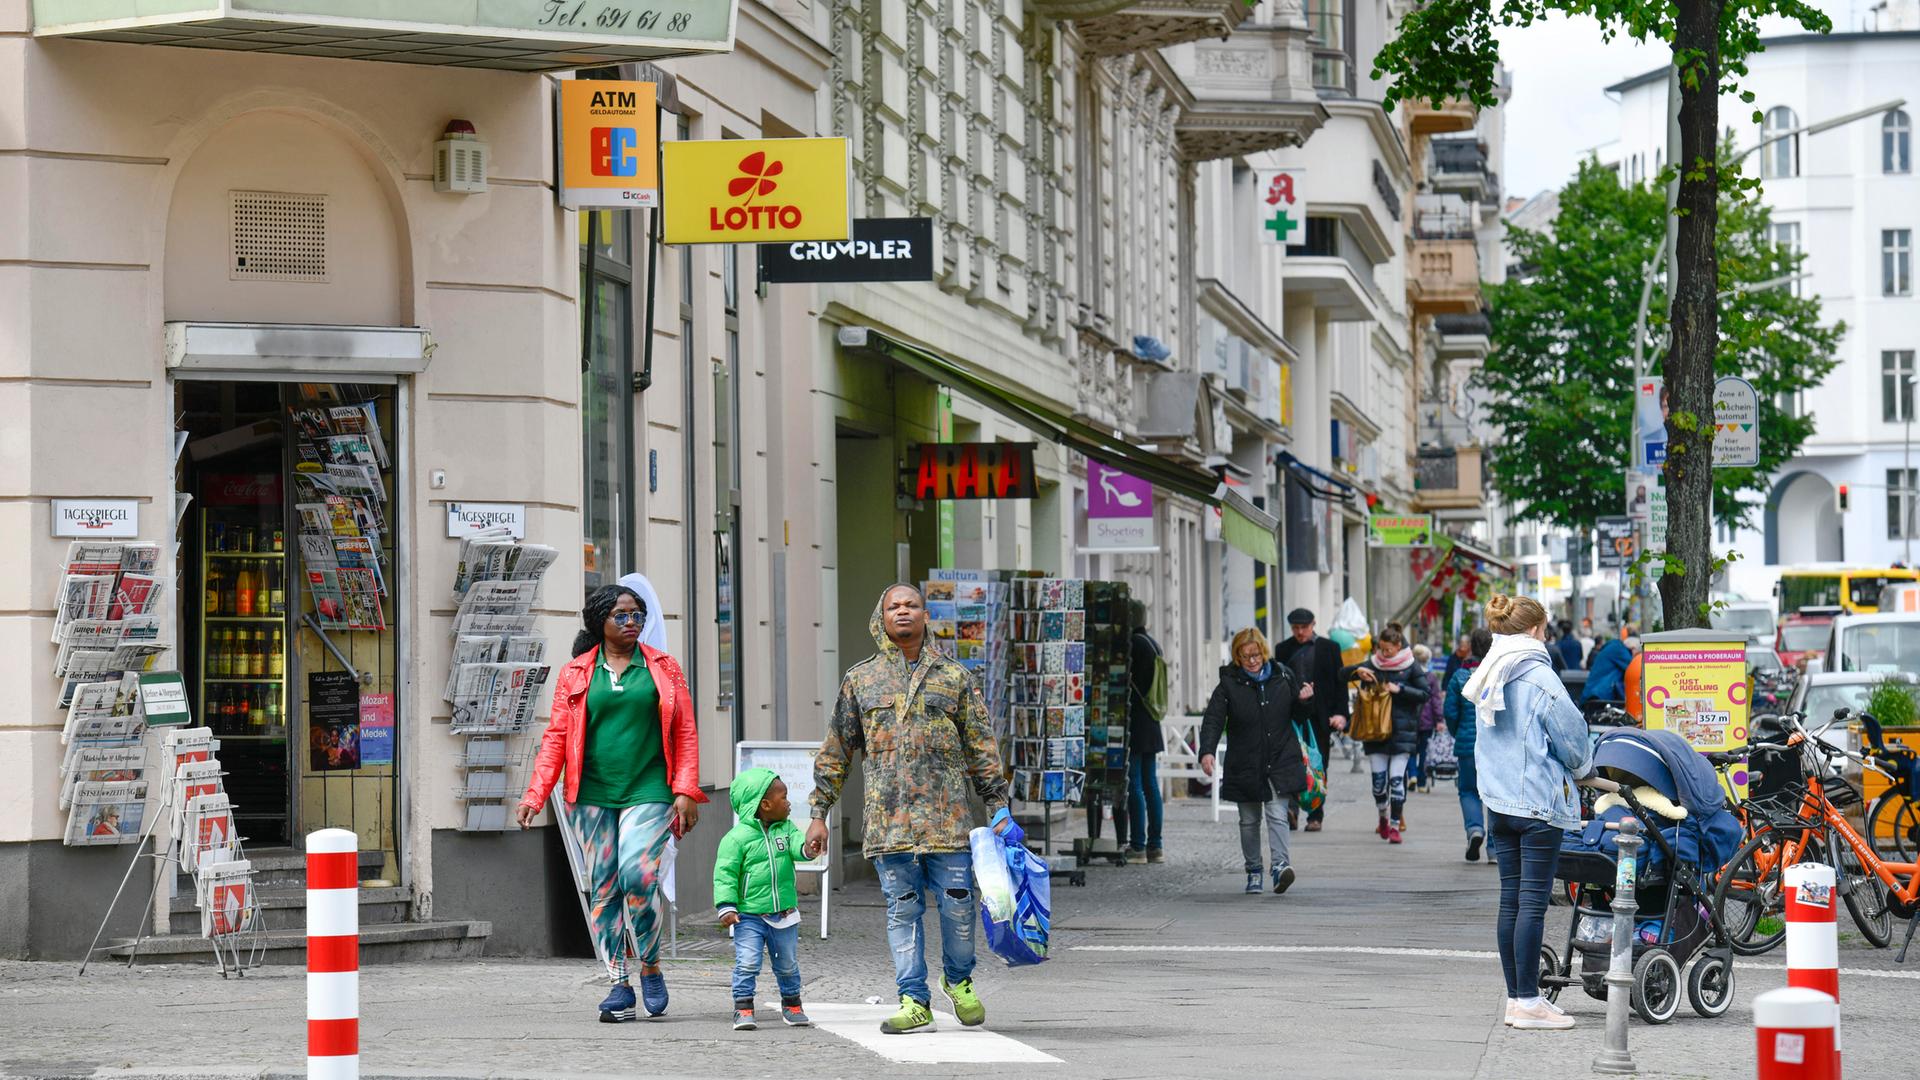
[{"xmin": 520, "ymin": 646, "xmax": 707, "ymax": 809}]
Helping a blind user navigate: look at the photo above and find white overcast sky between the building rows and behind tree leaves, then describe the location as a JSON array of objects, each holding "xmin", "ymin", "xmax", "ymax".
[{"xmin": 1496, "ymin": 0, "xmax": 1870, "ymax": 198}]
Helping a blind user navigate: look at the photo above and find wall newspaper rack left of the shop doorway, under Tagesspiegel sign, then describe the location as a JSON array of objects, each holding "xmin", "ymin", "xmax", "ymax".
[{"xmin": 54, "ymin": 540, "xmax": 169, "ymax": 847}]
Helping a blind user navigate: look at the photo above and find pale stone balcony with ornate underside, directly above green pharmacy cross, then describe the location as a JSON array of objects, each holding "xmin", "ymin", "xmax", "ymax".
[{"xmin": 1162, "ymin": 23, "xmax": 1327, "ymax": 161}]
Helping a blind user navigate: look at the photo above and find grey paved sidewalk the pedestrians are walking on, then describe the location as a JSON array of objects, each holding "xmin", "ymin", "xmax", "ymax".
[{"xmin": 0, "ymin": 761, "xmax": 1920, "ymax": 1080}]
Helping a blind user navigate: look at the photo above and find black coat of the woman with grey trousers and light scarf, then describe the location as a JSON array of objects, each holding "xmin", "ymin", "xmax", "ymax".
[{"xmin": 1200, "ymin": 663, "xmax": 1308, "ymax": 803}]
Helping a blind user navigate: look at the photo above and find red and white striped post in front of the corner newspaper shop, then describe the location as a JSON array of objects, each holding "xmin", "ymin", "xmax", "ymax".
[{"xmin": 307, "ymin": 828, "xmax": 359, "ymax": 1080}]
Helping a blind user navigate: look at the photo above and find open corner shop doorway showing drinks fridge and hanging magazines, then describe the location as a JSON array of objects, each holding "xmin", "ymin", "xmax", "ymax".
[{"xmin": 177, "ymin": 380, "xmax": 401, "ymax": 880}]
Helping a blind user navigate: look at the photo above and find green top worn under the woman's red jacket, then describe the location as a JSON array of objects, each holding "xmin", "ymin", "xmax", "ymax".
[{"xmin": 576, "ymin": 653, "xmax": 674, "ymax": 809}]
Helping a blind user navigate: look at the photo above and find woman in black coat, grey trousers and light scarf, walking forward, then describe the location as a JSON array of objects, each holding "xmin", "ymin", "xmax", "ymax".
[{"xmin": 1198, "ymin": 626, "xmax": 1308, "ymax": 894}]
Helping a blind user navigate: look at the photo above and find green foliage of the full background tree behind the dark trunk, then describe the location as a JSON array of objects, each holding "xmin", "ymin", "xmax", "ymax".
[{"xmin": 1478, "ymin": 160, "xmax": 1843, "ymax": 528}]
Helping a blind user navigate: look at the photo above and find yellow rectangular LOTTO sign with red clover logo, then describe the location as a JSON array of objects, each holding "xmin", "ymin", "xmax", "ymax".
[{"xmin": 662, "ymin": 138, "xmax": 852, "ymax": 244}]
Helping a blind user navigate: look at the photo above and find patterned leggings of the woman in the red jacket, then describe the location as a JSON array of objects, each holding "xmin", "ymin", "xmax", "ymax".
[{"xmin": 568, "ymin": 803, "xmax": 672, "ymax": 982}]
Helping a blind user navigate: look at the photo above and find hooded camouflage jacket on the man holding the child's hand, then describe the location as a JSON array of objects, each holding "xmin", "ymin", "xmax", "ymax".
[{"xmin": 810, "ymin": 594, "xmax": 1006, "ymax": 859}]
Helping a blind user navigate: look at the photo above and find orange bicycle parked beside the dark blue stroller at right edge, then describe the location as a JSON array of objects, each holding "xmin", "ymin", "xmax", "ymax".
[{"xmin": 1713, "ymin": 709, "xmax": 1920, "ymax": 963}]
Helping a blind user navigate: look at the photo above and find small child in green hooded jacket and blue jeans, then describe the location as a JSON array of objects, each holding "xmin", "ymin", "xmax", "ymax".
[{"xmin": 714, "ymin": 769, "xmax": 812, "ymax": 1032}]
